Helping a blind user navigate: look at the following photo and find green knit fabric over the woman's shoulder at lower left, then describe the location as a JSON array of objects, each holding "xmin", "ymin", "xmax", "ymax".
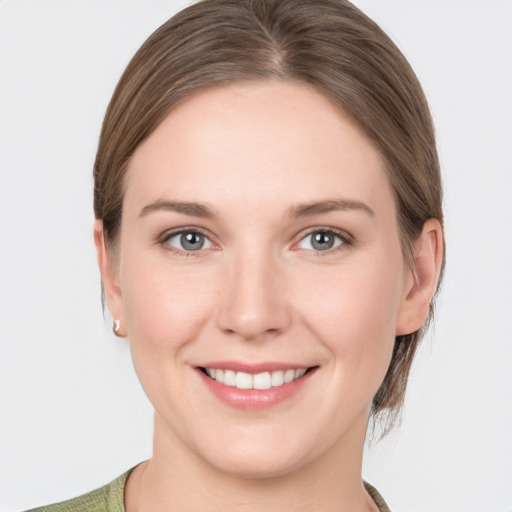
[{"xmin": 27, "ymin": 468, "xmax": 135, "ymax": 512}]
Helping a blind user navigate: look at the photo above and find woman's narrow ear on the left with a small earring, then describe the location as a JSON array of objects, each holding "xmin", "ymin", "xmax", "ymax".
[{"xmin": 94, "ymin": 219, "xmax": 126, "ymax": 336}]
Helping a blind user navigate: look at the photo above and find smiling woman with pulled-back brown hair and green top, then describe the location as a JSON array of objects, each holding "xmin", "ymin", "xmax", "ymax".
[{"xmin": 28, "ymin": 0, "xmax": 444, "ymax": 512}]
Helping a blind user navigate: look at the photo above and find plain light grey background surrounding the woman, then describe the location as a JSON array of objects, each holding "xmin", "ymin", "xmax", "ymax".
[{"xmin": 0, "ymin": 0, "xmax": 512, "ymax": 512}]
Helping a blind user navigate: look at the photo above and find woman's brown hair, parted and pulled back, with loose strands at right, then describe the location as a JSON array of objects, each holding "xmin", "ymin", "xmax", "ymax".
[{"xmin": 94, "ymin": 0, "xmax": 444, "ymax": 431}]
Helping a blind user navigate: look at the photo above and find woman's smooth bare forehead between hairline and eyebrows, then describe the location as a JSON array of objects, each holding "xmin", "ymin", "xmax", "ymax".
[{"xmin": 125, "ymin": 81, "xmax": 393, "ymax": 220}]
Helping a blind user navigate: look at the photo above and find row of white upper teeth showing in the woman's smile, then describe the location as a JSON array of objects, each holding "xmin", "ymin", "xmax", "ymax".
[{"xmin": 205, "ymin": 368, "xmax": 307, "ymax": 389}]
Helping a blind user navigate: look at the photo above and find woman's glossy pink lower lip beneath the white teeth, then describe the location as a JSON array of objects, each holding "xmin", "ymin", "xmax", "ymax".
[{"xmin": 197, "ymin": 369, "xmax": 315, "ymax": 409}]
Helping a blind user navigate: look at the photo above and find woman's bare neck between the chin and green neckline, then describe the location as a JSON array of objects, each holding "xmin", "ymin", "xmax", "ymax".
[{"xmin": 125, "ymin": 414, "xmax": 377, "ymax": 512}]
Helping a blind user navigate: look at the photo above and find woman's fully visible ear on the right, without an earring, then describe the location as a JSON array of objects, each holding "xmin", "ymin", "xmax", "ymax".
[{"xmin": 396, "ymin": 219, "xmax": 444, "ymax": 336}]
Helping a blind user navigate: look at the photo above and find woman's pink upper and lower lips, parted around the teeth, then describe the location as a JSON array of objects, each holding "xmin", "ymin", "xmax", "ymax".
[{"xmin": 197, "ymin": 361, "xmax": 316, "ymax": 410}]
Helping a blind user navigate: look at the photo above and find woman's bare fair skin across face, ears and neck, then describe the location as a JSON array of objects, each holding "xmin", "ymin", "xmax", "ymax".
[{"xmin": 95, "ymin": 82, "xmax": 442, "ymax": 512}]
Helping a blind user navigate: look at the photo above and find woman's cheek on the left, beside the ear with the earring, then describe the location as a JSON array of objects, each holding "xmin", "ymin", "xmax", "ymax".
[{"xmin": 121, "ymin": 253, "xmax": 222, "ymax": 411}]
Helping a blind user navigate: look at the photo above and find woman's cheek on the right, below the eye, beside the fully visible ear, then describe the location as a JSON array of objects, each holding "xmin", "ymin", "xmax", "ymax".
[{"xmin": 301, "ymin": 255, "xmax": 403, "ymax": 386}]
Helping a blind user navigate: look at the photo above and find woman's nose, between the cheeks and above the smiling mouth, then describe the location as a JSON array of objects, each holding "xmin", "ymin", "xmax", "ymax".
[{"xmin": 217, "ymin": 247, "xmax": 292, "ymax": 341}]
